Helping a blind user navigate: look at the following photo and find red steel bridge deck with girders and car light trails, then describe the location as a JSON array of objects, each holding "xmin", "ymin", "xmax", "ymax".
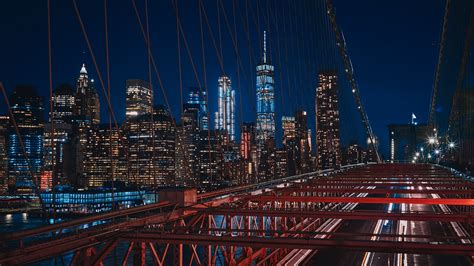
[{"xmin": 0, "ymin": 164, "xmax": 474, "ymax": 265}]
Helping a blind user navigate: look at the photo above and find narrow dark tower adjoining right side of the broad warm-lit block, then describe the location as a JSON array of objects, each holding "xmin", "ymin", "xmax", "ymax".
[{"xmin": 176, "ymin": 103, "xmax": 200, "ymax": 186}]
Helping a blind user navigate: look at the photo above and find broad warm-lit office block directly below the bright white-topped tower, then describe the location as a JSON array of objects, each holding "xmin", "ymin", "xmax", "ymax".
[{"xmin": 125, "ymin": 105, "xmax": 176, "ymax": 187}]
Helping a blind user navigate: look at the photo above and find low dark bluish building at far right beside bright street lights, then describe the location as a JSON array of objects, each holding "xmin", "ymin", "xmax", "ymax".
[{"xmin": 388, "ymin": 124, "xmax": 430, "ymax": 162}]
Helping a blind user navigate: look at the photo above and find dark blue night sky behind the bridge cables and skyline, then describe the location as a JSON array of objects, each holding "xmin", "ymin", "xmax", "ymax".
[{"xmin": 0, "ymin": 0, "xmax": 445, "ymax": 158}]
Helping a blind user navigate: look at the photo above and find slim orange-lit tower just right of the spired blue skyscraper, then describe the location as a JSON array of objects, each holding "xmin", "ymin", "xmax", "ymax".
[{"xmin": 281, "ymin": 116, "xmax": 299, "ymax": 175}]
